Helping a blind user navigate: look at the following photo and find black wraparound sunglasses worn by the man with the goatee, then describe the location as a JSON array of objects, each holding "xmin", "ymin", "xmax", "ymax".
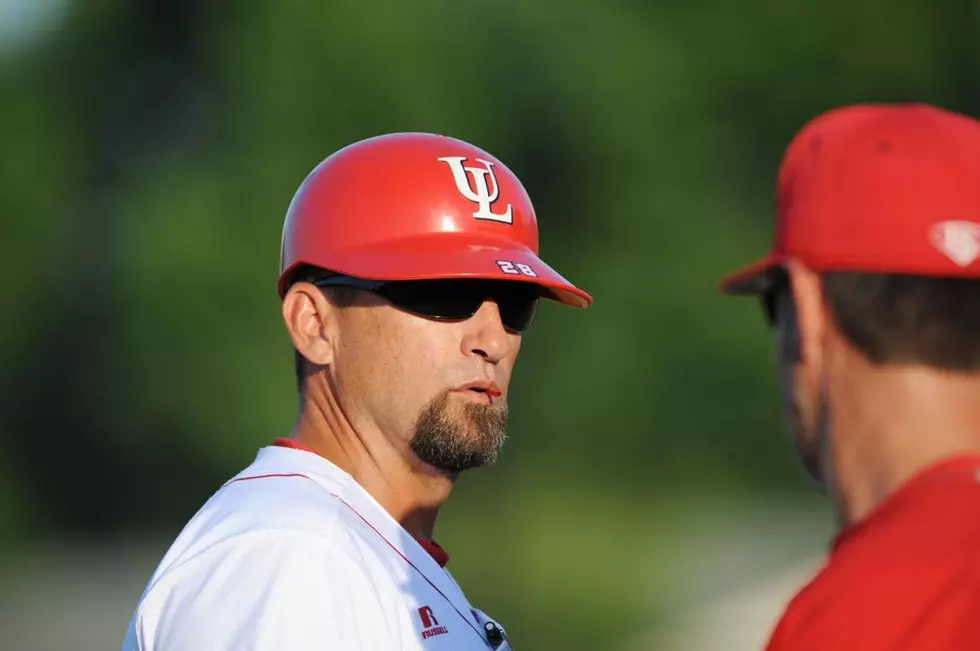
[{"xmin": 310, "ymin": 276, "xmax": 540, "ymax": 332}]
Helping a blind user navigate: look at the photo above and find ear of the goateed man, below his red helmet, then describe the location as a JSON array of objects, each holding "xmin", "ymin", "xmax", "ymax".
[{"xmin": 282, "ymin": 282, "xmax": 337, "ymax": 366}]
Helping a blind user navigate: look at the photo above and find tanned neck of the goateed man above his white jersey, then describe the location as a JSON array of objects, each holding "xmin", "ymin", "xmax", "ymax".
[{"xmin": 290, "ymin": 390, "xmax": 453, "ymax": 540}]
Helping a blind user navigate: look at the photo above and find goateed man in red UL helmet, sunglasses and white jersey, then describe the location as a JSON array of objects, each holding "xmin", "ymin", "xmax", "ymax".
[{"xmin": 116, "ymin": 133, "xmax": 591, "ymax": 651}]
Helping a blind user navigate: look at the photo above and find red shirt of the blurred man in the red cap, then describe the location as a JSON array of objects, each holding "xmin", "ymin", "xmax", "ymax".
[{"xmin": 767, "ymin": 456, "xmax": 980, "ymax": 651}]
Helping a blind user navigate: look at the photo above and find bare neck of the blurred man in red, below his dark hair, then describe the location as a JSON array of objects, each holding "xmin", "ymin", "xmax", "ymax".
[{"xmin": 830, "ymin": 367, "xmax": 980, "ymax": 525}]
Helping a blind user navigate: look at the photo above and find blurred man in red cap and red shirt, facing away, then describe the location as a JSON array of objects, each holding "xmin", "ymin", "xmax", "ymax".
[{"xmin": 723, "ymin": 104, "xmax": 980, "ymax": 651}]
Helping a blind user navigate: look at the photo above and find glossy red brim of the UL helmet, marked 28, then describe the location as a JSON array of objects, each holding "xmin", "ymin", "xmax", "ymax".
[{"xmin": 292, "ymin": 233, "xmax": 592, "ymax": 307}]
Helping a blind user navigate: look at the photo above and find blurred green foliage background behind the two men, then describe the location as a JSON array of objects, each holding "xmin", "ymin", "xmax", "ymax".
[{"xmin": 0, "ymin": 0, "xmax": 980, "ymax": 651}]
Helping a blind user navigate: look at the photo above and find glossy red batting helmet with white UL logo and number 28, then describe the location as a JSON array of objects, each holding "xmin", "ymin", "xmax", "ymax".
[{"xmin": 279, "ymin": 133, "xmax": 592, "ymax": 307}]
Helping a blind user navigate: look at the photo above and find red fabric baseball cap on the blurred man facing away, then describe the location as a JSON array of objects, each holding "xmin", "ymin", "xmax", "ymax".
[{"xmin": 721, "ymin": 104, "xmax": 980, "ymax": 294}]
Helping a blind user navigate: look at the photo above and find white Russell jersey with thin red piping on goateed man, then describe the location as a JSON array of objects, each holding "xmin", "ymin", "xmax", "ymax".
[{"xmin": 122, "ymin": 446, "xmax": 510, "ymax": 651}]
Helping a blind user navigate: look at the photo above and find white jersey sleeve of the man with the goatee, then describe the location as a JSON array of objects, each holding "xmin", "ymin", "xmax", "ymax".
[{"xmin": 124, "ymin": 530, "xmax": 404, "ymax": 651}]
